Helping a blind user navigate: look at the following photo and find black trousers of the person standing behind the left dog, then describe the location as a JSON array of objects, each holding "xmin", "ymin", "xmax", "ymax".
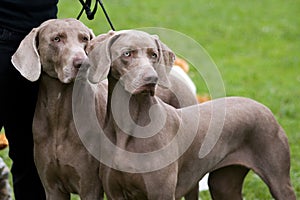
[{"xmin": 0, "ymin": 28, "xmax": 45, "ymax": 200}]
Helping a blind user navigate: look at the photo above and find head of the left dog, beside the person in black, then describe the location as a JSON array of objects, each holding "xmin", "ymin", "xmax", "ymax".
[{"xmin": 12, "ymin": 19, "xmax": 94, "ymax": 83}]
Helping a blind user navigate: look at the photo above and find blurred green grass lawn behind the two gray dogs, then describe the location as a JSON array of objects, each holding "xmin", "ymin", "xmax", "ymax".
[{"xmin": 2, "ymin": 0, "xmax": 300, "ymax": 200}]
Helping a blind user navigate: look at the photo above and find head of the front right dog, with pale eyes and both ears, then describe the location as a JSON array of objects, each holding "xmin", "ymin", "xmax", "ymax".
[{"xmin": 89, "ymin": 30, "xmax": 175, "ymax": 95}]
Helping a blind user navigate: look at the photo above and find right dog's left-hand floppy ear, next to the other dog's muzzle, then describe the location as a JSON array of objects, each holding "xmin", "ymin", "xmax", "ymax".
[{"xmin": 88, "ymin": 35, "xmax": 119, "ymax": 83}]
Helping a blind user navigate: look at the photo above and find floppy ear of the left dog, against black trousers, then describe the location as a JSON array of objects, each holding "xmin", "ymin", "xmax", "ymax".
[{"xmin": 11, "ymin": 28, "xmax": 41, "ymax": 81}]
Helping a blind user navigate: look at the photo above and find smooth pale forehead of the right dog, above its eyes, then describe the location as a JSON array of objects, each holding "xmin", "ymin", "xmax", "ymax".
[{"xmin": 112, "ymin": 31, "xmax": 158, "ymax": 51}]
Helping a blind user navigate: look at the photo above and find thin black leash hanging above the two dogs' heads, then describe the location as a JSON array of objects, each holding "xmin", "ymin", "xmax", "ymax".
[{"xmin": 77, "ymin": 0, "xmax": 115, "ymax": 31}]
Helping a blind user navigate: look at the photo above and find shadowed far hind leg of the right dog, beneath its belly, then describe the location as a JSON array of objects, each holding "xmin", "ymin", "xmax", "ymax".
[{"xmin": 208, "ymin": 165, "xmax": 249, "ymax": 200}]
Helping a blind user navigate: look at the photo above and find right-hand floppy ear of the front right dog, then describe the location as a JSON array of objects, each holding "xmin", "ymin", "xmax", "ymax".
[{"xmin": 155, "ymin": 36, "xmax": 175, "ymax": 88}]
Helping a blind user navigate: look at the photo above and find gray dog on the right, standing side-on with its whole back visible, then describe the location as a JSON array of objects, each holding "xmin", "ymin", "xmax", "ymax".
[{"xmin": 89, "ymin": 30, "xmax": 296, "ymax": 200}]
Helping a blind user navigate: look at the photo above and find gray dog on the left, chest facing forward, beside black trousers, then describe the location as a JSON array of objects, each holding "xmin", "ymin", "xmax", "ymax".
[{"xmin": 12, "ymin": 19, "xmax": 107, "ymax": 200}]
